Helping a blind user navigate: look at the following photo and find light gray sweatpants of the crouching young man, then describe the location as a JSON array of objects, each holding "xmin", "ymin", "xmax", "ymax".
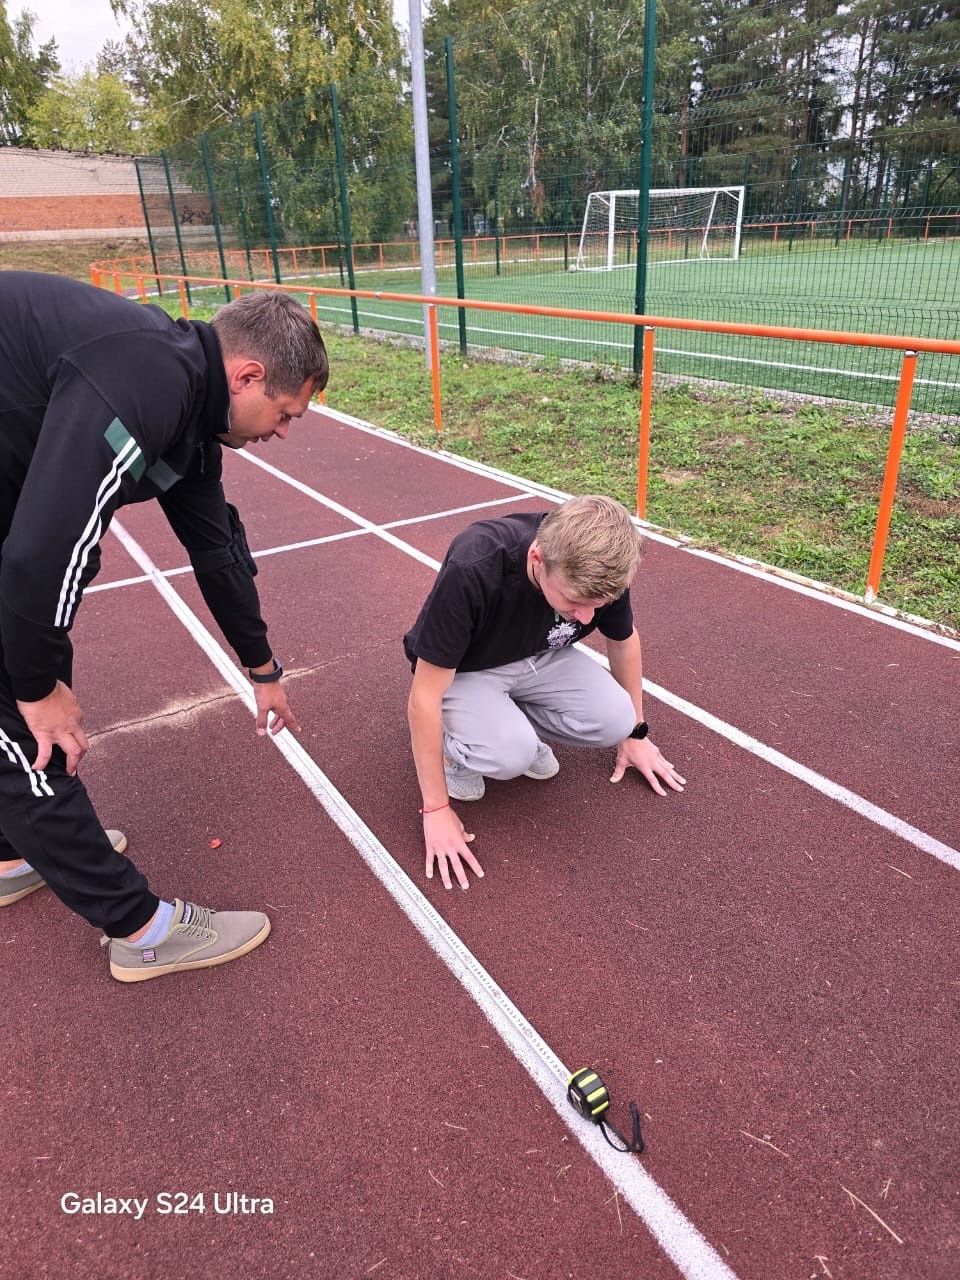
[{"xmin": 443, "ymin": 648, "xmax": 636, "ymax": 781}]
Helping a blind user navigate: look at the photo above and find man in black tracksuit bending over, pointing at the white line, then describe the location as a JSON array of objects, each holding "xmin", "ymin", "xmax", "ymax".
[{"xmin": 0, "ymin": 271, "xmax": 326, "ymax": 982}]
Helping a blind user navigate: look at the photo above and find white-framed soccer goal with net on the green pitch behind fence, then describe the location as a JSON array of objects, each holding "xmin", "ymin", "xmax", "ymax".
[{"xmin": 571, "ymin": 187, "xmax": 744, "ymax": 271}]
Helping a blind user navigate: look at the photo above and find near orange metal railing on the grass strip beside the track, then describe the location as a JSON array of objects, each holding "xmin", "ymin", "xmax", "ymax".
[{"xmin": 91, "ymin": 262, "xmax": 960, "ymax": 603}]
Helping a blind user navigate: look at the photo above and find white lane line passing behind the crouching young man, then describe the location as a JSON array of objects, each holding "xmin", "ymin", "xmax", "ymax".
[{"xmin": 237, "ymin": 440, "xmax": 960, "ymax": 870}]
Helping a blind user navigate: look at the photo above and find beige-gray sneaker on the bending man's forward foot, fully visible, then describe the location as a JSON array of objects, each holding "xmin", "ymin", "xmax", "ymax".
[{"xmin": 108, "ymin": 897, "xmax": 270, "ymax": 982}]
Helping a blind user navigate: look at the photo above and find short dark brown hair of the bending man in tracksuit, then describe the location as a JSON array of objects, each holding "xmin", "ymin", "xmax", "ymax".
[{"xmin": 212, "ymin": 289, "xmax": 329, "ymax": 399}]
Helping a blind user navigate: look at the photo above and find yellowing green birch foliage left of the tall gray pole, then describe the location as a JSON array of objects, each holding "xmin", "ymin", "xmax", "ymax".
[{"xmin": 123, "ymin": 0, "xmax": 415, "ymax": 244}]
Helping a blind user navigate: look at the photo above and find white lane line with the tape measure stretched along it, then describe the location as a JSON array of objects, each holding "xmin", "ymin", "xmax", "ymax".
[{"xmin": 110, "ymin": 520, "xmax": 736, "ymax": 1280}]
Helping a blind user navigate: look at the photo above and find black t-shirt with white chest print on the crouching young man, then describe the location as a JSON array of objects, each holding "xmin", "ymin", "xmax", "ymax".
[{"xmin": 403, "ymin": 512, "xmax": 634, "ymax": 671}]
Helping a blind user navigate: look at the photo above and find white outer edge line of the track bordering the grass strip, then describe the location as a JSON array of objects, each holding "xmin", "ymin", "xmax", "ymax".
[{"xmin": 315, "ymin": 406, "xmax": 960, "ymax": 652}]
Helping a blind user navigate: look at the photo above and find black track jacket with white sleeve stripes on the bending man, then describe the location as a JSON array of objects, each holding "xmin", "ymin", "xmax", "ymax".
[{"xmin": 0, "ymin": 271, "xmax": 271, "ymax": 701}]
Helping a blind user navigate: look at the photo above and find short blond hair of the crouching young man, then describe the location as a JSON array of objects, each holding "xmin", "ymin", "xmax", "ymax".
[{"xmin": 536, "ymin": 494, "xmax": 643, "ymax": 600}]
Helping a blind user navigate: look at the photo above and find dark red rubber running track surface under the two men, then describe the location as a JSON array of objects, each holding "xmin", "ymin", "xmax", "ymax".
[{"xmin": 0, "ymin": 413, "xmax": 960, "ymax": 1280}]
